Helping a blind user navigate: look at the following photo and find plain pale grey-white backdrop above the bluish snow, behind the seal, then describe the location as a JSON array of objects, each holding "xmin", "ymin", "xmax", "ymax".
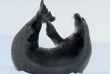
[{"xmin": 0, "ymin": 0, "xmax": 110, "ymax": 43}]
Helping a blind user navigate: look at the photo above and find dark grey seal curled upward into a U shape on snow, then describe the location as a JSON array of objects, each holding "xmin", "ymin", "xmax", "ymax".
[{"xmin": 12, "ymin": 0, "xmax": 91, "ymax": 74}]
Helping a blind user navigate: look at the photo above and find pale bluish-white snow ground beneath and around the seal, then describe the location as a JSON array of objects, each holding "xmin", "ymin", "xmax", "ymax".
[{"xmin": 0, "ymin": 35, "xmax": 110, "ymax": 74}]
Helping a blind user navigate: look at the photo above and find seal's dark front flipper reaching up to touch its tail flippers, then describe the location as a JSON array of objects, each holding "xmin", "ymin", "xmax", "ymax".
[{"xmin": 46, "ymin": 22, "xmax": 64, "ymax": 45}]
